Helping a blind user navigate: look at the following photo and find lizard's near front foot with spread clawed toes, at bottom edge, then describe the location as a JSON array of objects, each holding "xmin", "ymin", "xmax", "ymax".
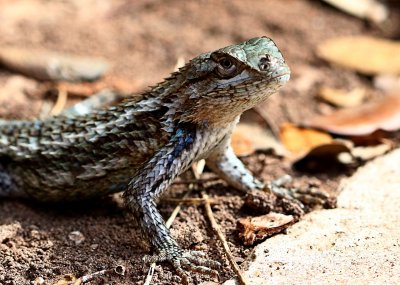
[{"xmin": 144, "ymin": 247, "xmax": 221, "ymax": 284}]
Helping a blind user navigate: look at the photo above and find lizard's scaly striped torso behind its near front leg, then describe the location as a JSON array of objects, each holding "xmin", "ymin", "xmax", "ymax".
[{"xmin": 0, "ymin": 104, "xmax": 167, "ymax": 200}]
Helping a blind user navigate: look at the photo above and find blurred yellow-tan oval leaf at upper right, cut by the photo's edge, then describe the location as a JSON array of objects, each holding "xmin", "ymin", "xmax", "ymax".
[{"xmin": 318, "ymin": 36, "xmax": 400, "ymax": 75}]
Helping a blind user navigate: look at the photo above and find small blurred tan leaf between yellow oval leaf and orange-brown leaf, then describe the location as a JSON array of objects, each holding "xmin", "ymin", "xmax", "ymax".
[{"xmin": 317, "ymin": 87, "xmax": 367, "ymax": 107}]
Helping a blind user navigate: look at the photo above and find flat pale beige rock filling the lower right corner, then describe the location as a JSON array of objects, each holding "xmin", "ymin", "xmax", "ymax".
[{"xmin": 224, "ymin": 149, "xmax": 400, "ymax": 285}]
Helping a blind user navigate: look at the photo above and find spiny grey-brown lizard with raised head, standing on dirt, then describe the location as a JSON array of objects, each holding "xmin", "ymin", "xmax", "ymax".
[{"xmin": 0, "ymin": 37, "xmax": 300, "ymax": 283}]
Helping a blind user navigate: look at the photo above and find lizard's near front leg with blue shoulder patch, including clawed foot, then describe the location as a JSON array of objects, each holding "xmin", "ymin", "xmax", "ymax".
[{"xmin": 124, "ymin": 129, "xmax": 220, "ymax": 283}]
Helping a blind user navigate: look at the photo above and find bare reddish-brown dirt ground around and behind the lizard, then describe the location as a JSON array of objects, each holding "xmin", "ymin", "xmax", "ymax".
[{"xmin": 0, "ymin": 0, "xmax": 400, "ymax": 285}]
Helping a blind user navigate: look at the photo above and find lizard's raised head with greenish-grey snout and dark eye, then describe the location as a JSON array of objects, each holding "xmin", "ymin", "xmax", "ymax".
[{"xmin": 166, "ymin": 37, "xmax": 290, "ymax": 126}]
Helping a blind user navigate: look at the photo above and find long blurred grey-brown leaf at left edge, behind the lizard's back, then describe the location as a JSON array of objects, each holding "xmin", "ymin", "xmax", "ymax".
[{"xmin": 0, "ymin": 47, "xmax": 109, "ymax": 81}]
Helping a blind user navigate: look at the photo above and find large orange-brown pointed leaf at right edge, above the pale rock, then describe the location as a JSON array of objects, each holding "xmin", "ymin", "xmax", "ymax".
[{"xmin": 304, "ymin": 94, "xmax": 400, "ymax": 136}]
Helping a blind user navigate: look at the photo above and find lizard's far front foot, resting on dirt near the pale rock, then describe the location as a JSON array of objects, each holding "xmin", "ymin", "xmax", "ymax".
[{"xmin": 264, "ymin": 175, "xmax": 334, "ymax": 208}]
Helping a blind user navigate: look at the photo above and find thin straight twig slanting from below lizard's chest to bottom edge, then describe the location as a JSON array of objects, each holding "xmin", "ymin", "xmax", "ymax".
[{"xmin": 201, "ymin": 191, "xmax": 249, "ymax": 285}]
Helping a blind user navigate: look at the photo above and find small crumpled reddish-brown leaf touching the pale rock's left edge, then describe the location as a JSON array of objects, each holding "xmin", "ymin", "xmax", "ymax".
[{"xmin": 237, "ymin": 212, "xmax": 295, "ymax": 245}]
